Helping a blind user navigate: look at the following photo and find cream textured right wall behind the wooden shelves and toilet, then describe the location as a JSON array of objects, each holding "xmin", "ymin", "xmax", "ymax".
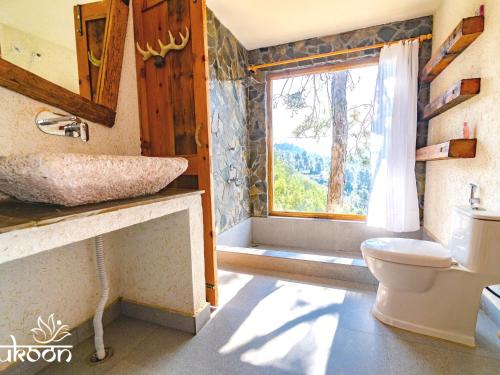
[{"xmin": 424, "ymin": 0, "xmax": 500, "ymax": 243}]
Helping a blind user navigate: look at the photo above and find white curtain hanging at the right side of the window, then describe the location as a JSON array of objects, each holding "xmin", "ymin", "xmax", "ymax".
[{"xmin": 367, "ymin": 41, "xmax": 420, "ymax": 232}]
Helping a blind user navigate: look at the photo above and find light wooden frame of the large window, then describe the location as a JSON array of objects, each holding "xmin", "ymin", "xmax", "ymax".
[{"xmin": 266, "ymin": 56, "xmax": 379, "ymax": 221}]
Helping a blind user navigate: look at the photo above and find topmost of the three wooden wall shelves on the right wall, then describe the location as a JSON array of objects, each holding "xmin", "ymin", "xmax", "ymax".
[{"xmin": 421, "ymin": 16, "xmax": 484, "ymax": 82}]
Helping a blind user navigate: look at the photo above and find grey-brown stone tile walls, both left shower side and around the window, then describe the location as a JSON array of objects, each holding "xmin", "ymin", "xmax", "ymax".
[{"xmin": 207, "ymin": 10, "xmax": 432, "ymax": 229}]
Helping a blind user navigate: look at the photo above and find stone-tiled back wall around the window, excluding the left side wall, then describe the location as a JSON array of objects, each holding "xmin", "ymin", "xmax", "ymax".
[{"xmin": 247, "ymin": 16, "xmax": 432, "ymax": 223}]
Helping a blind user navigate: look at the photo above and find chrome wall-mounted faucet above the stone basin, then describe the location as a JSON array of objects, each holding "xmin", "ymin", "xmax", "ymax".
[{"xmin": 35, "ymin": 111, "xmax": 89, "ymax": 142}]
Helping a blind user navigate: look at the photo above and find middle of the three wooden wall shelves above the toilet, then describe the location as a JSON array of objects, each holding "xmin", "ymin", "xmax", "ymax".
[{"xmin": 422, "ymin": 78, "xmax": 481, "ymax": 120}]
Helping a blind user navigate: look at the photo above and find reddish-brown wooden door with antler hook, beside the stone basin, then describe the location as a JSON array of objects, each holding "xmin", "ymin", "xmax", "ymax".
[{"xmin": 132, "ymin": 0, "xmax": 217, "ymax": 306}]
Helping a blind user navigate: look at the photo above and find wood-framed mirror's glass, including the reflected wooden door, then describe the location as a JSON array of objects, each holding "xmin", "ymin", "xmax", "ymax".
[{"xmin": 0, "ymin": 0, "xmax": 109, "ymax": 101}]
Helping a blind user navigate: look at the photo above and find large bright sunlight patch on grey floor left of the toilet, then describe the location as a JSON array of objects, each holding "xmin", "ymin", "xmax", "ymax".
[{"xmin": 219, "ymin": 274, "xmax": 346, "ymax": 374}]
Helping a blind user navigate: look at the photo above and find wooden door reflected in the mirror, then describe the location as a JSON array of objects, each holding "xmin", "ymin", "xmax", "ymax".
[{"xmin": 73, "ymin": 0, "xmax": 109, "ymax": 101}]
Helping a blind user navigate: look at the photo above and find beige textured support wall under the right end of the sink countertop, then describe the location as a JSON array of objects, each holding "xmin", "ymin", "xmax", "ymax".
[{"xmin": 115, "ymin": 203, "xmax": 206, "ymax": 315}]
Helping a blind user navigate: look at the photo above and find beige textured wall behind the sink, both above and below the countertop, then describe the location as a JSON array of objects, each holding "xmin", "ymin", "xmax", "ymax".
[{"xmin": 0, "ymin": 11, "xmax": 141, "ymax": 368}]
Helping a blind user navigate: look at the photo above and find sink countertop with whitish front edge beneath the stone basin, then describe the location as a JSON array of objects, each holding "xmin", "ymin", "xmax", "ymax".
[{"xmin": 0, "ymin": 188, "xmax": 203, "ymax": 263}]
